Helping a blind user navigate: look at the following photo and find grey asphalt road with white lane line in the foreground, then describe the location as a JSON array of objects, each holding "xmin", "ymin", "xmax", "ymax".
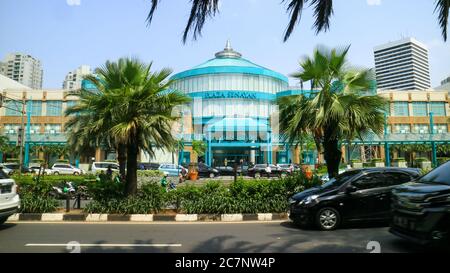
[{"xmin": 0, "ymin": 221, "xmax": 446, "ymax": 253}]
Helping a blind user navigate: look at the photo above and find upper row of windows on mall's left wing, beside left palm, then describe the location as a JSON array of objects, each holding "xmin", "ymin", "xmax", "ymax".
[{"xmin": 5, "ymin": 100, "xmax": 77, "ymax": 117}]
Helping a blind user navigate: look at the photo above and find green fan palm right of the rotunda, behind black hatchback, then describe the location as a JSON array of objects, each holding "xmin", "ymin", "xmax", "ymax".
[{"xmin": 278, "ymin": 47, "xmax": 387, "ymax": 177}]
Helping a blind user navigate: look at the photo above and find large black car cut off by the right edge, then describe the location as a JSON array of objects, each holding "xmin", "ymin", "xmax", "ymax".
[{"xmin": 390, "ymin": 162, "xmax": 450, "ymax": 245}]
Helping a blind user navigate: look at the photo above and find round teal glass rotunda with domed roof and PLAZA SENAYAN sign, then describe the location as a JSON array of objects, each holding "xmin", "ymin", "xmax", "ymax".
[{"xmin": 172, "ymin": 44, "xmax": 298, "ymax": 166}]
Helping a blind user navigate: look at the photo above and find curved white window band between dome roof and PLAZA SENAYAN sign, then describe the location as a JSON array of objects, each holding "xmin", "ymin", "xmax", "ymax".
[{"xmin": 173, "ymin": 74, "xmax": 288, "ymax": 94}]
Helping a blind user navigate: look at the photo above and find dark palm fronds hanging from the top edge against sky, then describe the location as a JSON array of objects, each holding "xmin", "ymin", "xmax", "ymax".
[{"xmin": 147, "ymin": 0, "xmax": 450, "ymax": 43}]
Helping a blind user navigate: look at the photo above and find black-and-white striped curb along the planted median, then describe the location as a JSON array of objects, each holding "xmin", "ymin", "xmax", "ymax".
[{"xmin": 8, "ymin": 213, "xmax": 289, "ymax": 223}]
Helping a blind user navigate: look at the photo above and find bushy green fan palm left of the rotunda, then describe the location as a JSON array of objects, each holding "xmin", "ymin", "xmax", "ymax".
[{"xmin": 66, "ymin": 58, "xmax": 190, "ymax": 195}]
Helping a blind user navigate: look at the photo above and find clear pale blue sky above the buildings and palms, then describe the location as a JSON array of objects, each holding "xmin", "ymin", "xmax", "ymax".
[{"xmin": 0, "ymin": 0, "xmax": 450, "ymax": 89}]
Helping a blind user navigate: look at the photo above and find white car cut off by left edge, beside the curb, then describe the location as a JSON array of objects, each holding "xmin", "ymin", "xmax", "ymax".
[{"xmin": 0, "ymin": 169, "xmax": 20, "ymax": 225}]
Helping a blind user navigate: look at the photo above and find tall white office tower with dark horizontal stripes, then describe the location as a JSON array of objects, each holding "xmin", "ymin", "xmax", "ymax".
[{"xmin": 374, "ymin": 38, "xmax": 431, "ymax": 90}]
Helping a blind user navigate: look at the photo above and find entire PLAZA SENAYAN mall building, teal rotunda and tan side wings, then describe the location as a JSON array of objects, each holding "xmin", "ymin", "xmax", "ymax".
[{"xmin": 0, "ymin": 43, "xmax": 450, "ymax": 166}]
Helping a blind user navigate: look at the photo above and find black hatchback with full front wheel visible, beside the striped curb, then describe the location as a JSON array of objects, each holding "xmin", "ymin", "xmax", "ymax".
[{"xmin": 289, "ymin": 168, "xmax": 420, "ymax": 230}]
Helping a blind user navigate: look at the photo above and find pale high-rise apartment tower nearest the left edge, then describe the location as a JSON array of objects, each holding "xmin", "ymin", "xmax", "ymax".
[{"xmin": 0, "ymin": 53, "xmax": 44, "ymax": 89}]
